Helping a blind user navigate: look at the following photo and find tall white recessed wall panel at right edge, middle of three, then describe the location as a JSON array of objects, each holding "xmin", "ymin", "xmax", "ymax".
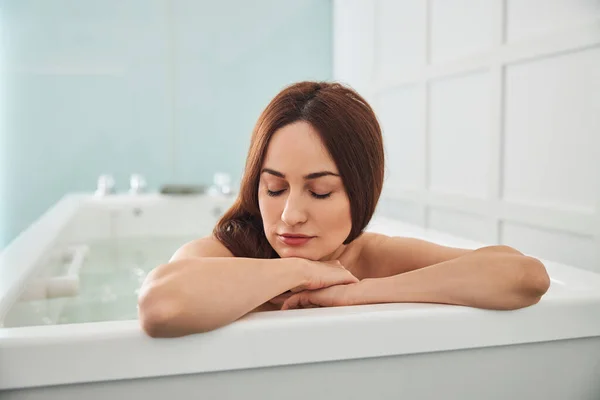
[{"xmin": 504, "ymin": 46, "xmax": 600, "ymax": 212}]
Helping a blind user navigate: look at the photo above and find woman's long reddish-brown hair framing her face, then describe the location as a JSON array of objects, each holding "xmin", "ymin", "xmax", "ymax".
[{"xmin": 213, "ymin": 82, "xmax": 384, "ymax": 258}]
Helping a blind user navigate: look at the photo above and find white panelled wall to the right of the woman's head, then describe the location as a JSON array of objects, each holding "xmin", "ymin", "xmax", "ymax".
[{"xmin": 334, "ymin": 0, "xmax": 600, "ymax": 272}]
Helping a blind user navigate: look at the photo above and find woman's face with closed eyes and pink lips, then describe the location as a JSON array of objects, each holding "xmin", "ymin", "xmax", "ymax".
[{"xmin": 258, "ymin": 121, "xmax": 352, "ymax": 260}]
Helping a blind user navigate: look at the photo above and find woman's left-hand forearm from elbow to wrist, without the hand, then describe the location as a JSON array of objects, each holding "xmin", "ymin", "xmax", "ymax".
[{"xmin": 139, "ymin": 258, "xmax": 304, "ymax": 337}]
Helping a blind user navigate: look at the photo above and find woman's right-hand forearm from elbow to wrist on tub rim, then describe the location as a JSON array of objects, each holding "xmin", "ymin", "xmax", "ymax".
[{"xmin": 357, "ymin": 248, "xmax": 549, "ymax": 309}]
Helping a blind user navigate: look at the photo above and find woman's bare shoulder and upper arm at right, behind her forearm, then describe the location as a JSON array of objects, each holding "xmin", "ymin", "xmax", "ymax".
[{"xmin": 352, "ymin": 232, "xmax": 472, "ymax": 278}]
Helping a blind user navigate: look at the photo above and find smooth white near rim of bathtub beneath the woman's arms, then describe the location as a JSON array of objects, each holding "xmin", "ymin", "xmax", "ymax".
[{"xmin": 0, "ymin": 293, "xmax": 600, "ymax": 390}]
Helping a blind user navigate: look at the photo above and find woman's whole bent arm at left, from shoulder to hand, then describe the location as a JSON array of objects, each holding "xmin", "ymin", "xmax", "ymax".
[{"xmin": 138, "ymin": 238, "xmax": 358, "ymax": 337}]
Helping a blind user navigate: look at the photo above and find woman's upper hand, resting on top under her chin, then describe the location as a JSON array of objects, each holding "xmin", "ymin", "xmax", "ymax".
[{"xmin": 290, "ymin": 259, "xmax": 359, "ymax": 293}]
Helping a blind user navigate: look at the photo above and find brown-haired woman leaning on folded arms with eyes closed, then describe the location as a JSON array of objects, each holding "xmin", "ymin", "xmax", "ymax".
[{"xmin": 139, "ymin": 82, "xmax": 550, "ymax": 337}]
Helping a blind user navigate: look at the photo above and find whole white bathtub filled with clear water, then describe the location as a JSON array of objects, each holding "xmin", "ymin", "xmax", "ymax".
[{"xmin": 0, "ymin": 194, "xmax": 600, "ymax": 400}]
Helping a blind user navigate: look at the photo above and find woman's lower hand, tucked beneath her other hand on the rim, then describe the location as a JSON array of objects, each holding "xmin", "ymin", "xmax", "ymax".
[{"xmin": 270, "ymin": 282, "xmax": 360, "ymax": 310}]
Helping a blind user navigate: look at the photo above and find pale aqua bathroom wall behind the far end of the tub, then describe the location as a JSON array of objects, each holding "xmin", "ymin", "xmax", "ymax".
[{"xmin": 0, "ymin": 0, "xmax": 332, "ymax": 249}]
